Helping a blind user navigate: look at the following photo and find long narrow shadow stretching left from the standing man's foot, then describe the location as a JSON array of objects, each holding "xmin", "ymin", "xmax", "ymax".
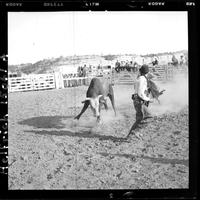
[{"xmin": 26, "ymin": 130, "xmax": 129, "ymax": 142}]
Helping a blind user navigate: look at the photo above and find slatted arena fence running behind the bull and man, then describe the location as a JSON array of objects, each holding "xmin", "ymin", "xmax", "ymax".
[{"xmin": 8, "ymin": 65, "xmax": 188, "ymax": 92}]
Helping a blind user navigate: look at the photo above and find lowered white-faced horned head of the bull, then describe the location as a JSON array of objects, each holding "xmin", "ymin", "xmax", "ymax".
[{"xmin": 82, "ymin": 95, "xmax": 105, "ymax": 119}]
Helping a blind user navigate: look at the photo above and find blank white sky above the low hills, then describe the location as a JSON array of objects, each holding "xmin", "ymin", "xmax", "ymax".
[{"xmin": 8, "ymin": 11, "xmax": 188, "ymax": 64}]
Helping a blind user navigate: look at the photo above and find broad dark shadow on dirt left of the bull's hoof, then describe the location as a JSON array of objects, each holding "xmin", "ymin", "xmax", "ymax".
[{"xmin": 19, "ymin": 116, "xmax": 73, "ymax": 129}]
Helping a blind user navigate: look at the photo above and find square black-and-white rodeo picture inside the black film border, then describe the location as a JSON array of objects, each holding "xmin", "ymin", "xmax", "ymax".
[{"xmin": 8, "ymin": 11, "xmax": 189, "ymax": 190}]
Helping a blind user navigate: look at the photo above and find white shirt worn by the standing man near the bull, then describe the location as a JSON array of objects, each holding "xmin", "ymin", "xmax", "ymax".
[{"xmin": 135, "ymin": 76, "xmax": 150, "ymax": 101}]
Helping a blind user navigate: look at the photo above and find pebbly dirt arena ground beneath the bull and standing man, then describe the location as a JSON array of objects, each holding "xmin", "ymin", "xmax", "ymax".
[{"xmin": 8, "ymin": 74, "xmax": 189, "ymax": 190}]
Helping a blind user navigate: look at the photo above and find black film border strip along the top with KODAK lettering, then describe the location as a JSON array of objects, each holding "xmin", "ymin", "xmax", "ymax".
[{"xmin": 0, "ymin": 0, "xmax": 196, "ymax": 11}]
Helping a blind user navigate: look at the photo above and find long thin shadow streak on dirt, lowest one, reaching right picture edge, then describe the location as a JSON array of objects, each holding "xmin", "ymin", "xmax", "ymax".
[{"xmin": 99, "ymin": 152, "xmax": 189, "ymax": 167}]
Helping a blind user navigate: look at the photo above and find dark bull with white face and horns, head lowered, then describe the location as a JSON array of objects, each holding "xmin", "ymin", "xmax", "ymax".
[{"xmin": 74, "ymin": 78, "xmax": 116, "ymax": 122}]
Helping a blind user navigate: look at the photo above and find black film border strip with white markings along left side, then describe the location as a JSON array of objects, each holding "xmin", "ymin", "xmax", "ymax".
[{"xmin": 0, "ymin": 9, "xmax": 8, "ymax": 190}]
